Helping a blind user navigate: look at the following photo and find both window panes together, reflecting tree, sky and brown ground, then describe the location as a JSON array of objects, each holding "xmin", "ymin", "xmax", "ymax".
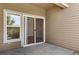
[{"xmin": 7, "ymin": 14, "xmax": 20, "ymax": 40}]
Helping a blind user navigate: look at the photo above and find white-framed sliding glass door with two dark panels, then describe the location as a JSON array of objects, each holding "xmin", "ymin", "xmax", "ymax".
[{"xmin": 24, "ymin": 16, "xmax": 44, "ymax": 45}]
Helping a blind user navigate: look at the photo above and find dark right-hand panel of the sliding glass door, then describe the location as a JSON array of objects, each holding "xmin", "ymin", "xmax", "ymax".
[{"xmin": 36, "ymin": 18, "xmax": 43, "ymax": 42}]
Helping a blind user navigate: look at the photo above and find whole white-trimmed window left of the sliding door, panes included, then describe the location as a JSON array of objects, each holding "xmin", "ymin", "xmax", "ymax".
[{"xmin": 4, "ymin": 10, "xmax": 21, "ymax": 43}]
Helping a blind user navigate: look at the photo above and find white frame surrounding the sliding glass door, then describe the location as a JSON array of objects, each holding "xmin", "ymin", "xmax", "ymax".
[{"xmin": 21, "ymin": 13, "xmax": 45, "ymax": 47}]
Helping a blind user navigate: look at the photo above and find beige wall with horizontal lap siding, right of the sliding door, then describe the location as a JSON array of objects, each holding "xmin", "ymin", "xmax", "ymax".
[{"xmin": 46, "ymin": 3, "xmax": 79, "ymax": 51}]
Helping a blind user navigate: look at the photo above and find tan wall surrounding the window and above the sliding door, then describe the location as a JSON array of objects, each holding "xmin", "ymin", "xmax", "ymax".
[{"xmin": 0, "ymin": 4, "xmax": 45, "ymax": 51}]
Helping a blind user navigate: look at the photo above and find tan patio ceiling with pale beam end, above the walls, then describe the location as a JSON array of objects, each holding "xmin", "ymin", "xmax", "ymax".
[{"xmin": 4, "ymin": 3, "xmax": 69, "ymax": 9}]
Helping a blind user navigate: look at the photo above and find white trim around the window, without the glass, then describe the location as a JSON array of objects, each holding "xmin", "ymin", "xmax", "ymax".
[{"xmin": 3, "ymin": 9, "xmax": 21, "ymax": 43}]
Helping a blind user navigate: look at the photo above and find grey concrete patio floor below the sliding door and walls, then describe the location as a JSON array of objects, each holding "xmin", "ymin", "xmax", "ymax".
[{"xmin": 0, "ymin": 43, "xmax": 73, "ymax": 55}]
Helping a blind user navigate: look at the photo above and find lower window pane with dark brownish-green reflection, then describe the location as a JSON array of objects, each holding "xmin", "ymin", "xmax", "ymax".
[{"xmin": 7, "ymin": 27, "xmax": 20, "ymax": 40}]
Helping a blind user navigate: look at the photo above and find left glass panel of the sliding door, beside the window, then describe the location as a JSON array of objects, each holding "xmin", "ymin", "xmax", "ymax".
[{"xmin": 27, "ymin": 17, "xmax": 34, "ymax": 44}]
